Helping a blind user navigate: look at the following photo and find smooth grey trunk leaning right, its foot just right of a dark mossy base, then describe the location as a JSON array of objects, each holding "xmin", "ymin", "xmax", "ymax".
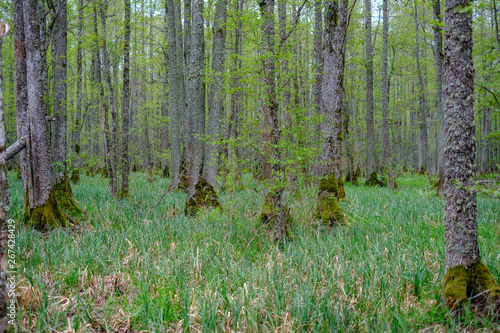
[{"xmin": 203, "ymin": 0, "xmax": 227, "ymax": 190}]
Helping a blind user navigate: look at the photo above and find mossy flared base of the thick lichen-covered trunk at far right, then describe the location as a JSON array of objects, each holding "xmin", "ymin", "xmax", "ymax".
[{"xmin": 443, "ymin": 260, "xmax": 500, "ymax": 310}]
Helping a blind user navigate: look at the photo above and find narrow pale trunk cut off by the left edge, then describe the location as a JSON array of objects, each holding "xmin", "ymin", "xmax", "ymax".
[{"xmin": 0, "ymin": 22, "xmax": 10, "ymax": 333}]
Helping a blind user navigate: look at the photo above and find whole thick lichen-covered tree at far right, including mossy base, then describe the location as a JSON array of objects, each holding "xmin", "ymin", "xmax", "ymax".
[{"xmin": 444, "ymin": 0, "xmax": 500, "ymax": 310}]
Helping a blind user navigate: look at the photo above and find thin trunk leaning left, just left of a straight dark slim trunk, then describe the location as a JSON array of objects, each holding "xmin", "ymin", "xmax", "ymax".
[{"xmin": 101, "ymin": 2, "xmax": 118, "ymax": 197}]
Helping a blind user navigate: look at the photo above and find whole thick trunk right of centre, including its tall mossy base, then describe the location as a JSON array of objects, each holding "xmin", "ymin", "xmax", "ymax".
[{"xmin": 316, "ymin": 0, "xmax": 350, "ymax": 224}]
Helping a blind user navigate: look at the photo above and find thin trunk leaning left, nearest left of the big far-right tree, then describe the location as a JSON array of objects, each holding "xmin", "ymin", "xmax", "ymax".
[{"xmin": 414, "ymin": 2, "xmax": 432, "ymax": 183}]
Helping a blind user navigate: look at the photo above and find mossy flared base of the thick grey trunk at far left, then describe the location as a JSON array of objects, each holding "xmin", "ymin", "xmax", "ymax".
[{"xmin": 22, "ymin": 188, "xmax": 68, "ymax": 230}]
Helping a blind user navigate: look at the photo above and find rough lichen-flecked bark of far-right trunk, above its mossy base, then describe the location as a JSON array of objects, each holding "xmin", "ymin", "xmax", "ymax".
[{"xmin": 444, "ymin": 0, "xmax": 480, "ymax": 271}]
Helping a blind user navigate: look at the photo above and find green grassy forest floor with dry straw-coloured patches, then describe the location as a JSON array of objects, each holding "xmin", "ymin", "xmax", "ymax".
[{"xmin": 9, "ymin": 173, "xmax": 500, "ymax": 332}]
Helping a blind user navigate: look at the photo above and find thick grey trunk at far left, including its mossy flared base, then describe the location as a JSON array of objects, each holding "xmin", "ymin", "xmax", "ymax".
[{"xmin": 21, "ymin": 0, "xmax": 67, "ymax": 229}]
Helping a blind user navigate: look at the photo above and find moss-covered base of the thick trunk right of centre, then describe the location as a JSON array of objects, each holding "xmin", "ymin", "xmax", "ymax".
[{"xmin": 315, "ymin": 175, "xmax": 346, "ymax": 225}]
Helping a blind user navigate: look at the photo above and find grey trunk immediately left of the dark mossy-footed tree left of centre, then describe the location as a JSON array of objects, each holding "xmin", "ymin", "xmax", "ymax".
[{"xmin": 165, "ymin": 0, "xmax": 184, "ymax": 189}]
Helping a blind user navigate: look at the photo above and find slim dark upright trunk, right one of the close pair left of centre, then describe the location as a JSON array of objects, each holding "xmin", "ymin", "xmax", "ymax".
[{"xmin": 120, "ymin": 0, "xmax": 130, "ymax": 198}]
